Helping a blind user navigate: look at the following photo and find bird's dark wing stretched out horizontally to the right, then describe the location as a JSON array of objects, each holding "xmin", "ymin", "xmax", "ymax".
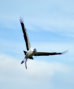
[{"xmin": 34, "ymin": 51, "xmax": 66, "ymax": 56}]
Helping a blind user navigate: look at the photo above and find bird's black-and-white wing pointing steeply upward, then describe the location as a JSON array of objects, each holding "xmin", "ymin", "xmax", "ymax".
[{"xmin": 20, "ymin": 19, "xmax": 31, "ymax": 50}]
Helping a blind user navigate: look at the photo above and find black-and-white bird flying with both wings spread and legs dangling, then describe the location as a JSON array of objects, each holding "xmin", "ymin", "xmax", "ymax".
[{"xmin": 20, "ymin": 19, "xmax": 65, "ymax": 69}]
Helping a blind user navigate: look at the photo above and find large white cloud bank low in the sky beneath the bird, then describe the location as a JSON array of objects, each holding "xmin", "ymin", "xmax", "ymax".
[{"xmin": 0, "ymin": 54, "xmax": 70, "ymax": 89}]
